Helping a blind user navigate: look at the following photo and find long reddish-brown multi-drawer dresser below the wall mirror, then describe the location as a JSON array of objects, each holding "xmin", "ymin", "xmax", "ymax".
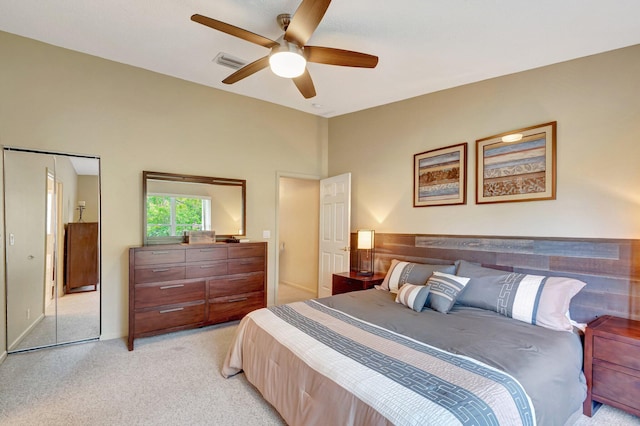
[{"xmin": 128, "ymin": 243, "xmax": 267, "ymax": 351}]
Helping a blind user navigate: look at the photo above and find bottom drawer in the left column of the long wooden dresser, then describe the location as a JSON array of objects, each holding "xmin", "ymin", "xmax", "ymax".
[{"xmin": 134, "ymin": 300, "xmax": 205, "ymax": 334}]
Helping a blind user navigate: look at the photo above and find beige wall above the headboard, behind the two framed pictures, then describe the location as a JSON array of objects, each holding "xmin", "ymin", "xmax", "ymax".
[{"xmin": 329, "ymin": 45, "xmax": 640, "ymax": 238}]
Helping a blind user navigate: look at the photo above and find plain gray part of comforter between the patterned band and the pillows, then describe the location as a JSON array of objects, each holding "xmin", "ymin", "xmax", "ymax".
[{"xmin": 318, "ymin": 290, "xmax": 586, "ymax": 425}]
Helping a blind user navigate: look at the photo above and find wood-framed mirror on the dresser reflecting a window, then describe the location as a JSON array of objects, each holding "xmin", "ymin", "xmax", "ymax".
[{"xmin": 142, "ymin": 171, "xmax": 246, "ymax": 245}]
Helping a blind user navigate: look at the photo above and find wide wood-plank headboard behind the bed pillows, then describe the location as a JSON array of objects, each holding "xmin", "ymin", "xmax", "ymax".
[{"xmin": 351, "ymin": 233, "xmax": 640, "ymax": 322}]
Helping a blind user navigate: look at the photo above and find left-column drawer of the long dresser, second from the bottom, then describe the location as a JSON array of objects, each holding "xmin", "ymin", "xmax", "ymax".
[{"xmin": 135, "ymin": 281, "xmax": 206, "ymax": 309}]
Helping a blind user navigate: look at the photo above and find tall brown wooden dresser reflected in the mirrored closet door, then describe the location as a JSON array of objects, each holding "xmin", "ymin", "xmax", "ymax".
[{"xmin": 64, "ymin": 222, "xmax": 99, "ymax": 293}]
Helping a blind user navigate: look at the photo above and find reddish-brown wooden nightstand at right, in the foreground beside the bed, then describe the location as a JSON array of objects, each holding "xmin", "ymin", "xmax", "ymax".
[{"xmin": 582, "ymin": 315, "xmax": 640, "ymax": 417}]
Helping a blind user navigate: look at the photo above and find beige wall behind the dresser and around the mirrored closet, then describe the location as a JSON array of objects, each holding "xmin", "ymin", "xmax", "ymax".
[{"xmin": 0, "ymin": 32, "xmax": 328, "ymax": 344}]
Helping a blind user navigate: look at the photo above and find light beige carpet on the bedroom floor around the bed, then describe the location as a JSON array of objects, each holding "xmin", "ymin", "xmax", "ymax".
[{"xmin": 0, "ymin": 322, "xmax": 640, "ymax": 426}]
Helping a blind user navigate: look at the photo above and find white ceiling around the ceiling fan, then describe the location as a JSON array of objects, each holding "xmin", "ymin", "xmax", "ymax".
[{"xmin": 0, "ymin": 0, "xmax": 640, "ymax": 117}]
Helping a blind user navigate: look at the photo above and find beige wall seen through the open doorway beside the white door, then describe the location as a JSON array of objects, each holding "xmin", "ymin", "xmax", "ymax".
[{"xmin": 278, "ymin": 177, "xmax": 320, "ymax": 293}]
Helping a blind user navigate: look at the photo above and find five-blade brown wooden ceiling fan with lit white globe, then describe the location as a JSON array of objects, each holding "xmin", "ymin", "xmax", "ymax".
[{"xmin": 191, "ymin": 0, "xmax": 378, "ymax": 99}]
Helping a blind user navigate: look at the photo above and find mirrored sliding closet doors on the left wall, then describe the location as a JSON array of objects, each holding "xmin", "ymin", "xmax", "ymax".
[{"xmin": 4, "ymin": 147, "xmax": 100, "ymax": 353}]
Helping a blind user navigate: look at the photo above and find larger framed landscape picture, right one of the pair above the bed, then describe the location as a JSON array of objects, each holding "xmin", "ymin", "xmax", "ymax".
[{"xmin": 476, "ymin": 121, "xmax": 556, "ymax": 204}]
